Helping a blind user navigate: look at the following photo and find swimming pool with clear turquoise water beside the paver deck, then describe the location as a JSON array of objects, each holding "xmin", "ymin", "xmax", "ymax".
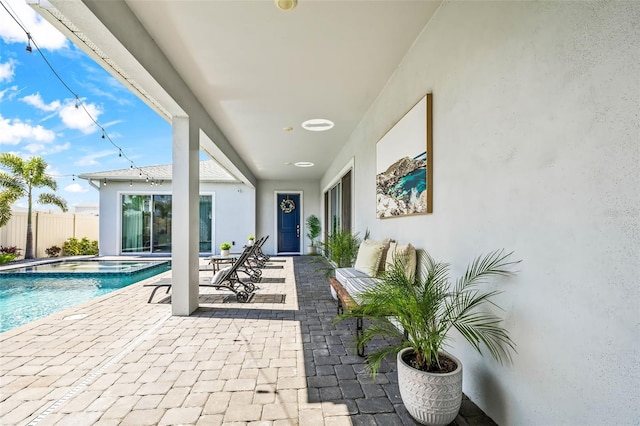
[{"xmin": 0, "ymin": 261, "xmax": 170, "ymax": 333}]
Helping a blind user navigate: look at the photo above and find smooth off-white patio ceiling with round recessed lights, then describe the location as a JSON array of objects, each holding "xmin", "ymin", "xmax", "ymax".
[{"xmin": 37, "ymin": 0, "xmax": 440, "ymax": 183}]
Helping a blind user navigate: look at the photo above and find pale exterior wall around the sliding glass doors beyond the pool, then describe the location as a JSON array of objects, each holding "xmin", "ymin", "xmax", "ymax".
[{"xmin": 95, "ymin": 182, "xmax": 256, "ymax": 256}]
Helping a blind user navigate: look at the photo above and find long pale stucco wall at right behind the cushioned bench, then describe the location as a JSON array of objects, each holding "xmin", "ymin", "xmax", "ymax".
[{"xmin": 321, "ymin": 2, "xmax": 640, "ymax": 425}]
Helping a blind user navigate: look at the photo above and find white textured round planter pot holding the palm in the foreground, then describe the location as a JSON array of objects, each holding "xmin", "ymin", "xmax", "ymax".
[{"xmin": 397, "ymin": 348, "xmax": 462, "ymax": 426}]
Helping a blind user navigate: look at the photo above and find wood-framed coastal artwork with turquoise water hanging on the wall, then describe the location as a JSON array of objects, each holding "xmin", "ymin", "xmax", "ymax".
[{"xmin": 376, "ymin": 93, "xmax": 433, "ymax": 219}]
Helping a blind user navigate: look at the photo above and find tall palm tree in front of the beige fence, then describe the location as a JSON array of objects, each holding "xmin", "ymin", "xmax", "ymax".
[{"xmin": 0, "ymin": 153, "xmax": 67, "ymax": 259}]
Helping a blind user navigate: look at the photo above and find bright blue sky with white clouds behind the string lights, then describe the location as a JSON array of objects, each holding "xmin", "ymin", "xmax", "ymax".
[{"xmin": 0, "ymin": 0, "xmax": 171, "ymax": 211}]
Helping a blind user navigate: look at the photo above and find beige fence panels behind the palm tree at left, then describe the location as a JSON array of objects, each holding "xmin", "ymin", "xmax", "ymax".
[{"xmin": 0, "ymin": 212, "xmax": 99, "ymax": 257}]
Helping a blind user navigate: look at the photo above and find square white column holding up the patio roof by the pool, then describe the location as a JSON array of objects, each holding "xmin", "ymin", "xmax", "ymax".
[{"xmin": 171, "ymin": 117, "xmax": 200, "ymax": 315}]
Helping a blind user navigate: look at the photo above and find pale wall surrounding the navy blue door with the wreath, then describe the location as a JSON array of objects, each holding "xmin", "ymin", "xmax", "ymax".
[{"xmin": 256, "ymin": 180, "xmax": 321, "ymax": 254}]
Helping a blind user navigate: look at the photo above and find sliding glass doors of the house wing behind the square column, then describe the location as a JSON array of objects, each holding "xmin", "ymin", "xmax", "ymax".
[{"xmin": 122, "ymin": 194, "xmax": 213, "ymax": 253}]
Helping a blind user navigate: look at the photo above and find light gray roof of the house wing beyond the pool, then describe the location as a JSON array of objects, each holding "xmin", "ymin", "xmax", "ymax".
[{"xmin": 78, "ymin": 160, "xmax": 239, "ymax": 182}]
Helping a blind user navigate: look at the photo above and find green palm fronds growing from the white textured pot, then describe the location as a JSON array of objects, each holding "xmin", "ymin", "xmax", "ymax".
[{"xmin": 338, "ymin": 250, "xmax": 519, "ymax": 376}]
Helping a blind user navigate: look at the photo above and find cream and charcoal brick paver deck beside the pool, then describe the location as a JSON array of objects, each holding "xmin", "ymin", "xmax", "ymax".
[{"xmin": 0, "ymin": 256, "xmax": 495, "ymax": 426}]
